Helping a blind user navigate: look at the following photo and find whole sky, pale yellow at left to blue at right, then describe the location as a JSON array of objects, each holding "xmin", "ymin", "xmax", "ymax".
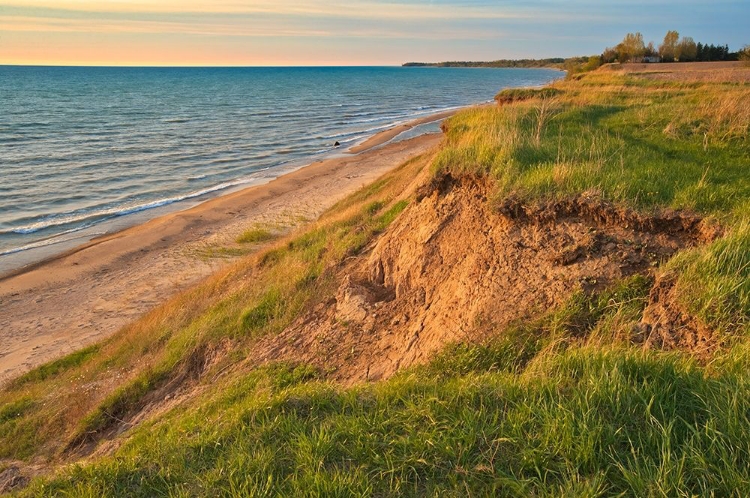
[{"xmin": 0, "ymin": 0, "xmax": 750, "ymax": 66}]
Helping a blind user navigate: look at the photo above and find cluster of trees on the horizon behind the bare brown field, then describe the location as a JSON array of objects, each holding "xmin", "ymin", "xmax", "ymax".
[{"xmin": 601, "ymin": 31, "xmax": 740, "ymax": 64}]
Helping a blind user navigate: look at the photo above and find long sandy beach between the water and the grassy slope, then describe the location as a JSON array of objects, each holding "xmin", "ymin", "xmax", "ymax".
[{"xmin": 0, "ymin": 126, "xmax": 446, "ymax": 382}]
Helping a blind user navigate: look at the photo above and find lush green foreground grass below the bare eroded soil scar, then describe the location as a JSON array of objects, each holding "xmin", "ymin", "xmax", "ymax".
[{"xmin": 27, "ymin": 347, "xmax": 750, "ymax": 496}]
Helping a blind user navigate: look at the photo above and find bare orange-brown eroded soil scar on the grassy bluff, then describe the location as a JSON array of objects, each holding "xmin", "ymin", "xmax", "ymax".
[{"xmin": 250, "ymin": 177, "xmax": 718, "ymax": 384}]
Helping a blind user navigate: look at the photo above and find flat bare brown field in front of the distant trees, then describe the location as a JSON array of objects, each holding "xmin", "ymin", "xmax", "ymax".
[{"xmin": 608, "ymin": 62, "xmax": 750, "ymax": 83}]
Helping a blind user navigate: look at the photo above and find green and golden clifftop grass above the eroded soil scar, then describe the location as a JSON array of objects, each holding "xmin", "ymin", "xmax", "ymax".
[{"xmin": 434, "ymin": 73, "xmax": 750, "ymax": 218}]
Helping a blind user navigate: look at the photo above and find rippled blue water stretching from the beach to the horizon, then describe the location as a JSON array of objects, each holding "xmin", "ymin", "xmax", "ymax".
[{"xmin": 0, "ymin": 67, "xmax": 561, "ymax": 266}]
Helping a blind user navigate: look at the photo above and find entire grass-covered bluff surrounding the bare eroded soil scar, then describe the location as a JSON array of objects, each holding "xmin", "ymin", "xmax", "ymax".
[{"xmin": 0, "ymin": 68, "xmax": 750, "ymax": 497}]
